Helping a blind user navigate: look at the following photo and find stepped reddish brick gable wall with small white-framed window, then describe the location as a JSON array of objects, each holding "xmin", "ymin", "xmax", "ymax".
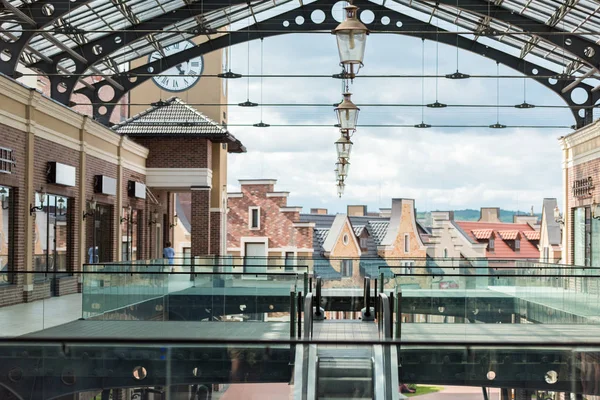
[{"xmin": 227, "ymin": 184, "xmax": 312, "ymax": 249}]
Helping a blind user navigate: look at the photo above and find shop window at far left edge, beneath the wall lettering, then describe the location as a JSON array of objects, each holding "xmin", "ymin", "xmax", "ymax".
[{"xmin": 0, "ymin": 186, "xmax": 15, "ymax": 285}]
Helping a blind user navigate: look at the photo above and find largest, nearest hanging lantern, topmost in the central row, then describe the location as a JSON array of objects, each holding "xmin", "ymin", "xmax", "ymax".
[{"xmin": 331, "ymin": 4, "xmax": 369, "ymax": 79}]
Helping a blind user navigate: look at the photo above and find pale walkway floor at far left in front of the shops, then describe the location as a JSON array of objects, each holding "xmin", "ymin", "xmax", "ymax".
[{"xmin": 0, "ymin": 293, "xmax": 81, "ymax": 337}]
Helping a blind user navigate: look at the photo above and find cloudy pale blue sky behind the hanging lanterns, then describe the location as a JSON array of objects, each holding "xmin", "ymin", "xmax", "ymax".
[{"xmin": 224, "ymin": 26, "xmax": 574, "ymax": 212}]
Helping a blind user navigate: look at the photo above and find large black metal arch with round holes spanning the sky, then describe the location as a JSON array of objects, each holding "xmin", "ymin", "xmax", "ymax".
[{"xmin": 61, "ymin": 0, "xmax": 600, "ymax": 127}]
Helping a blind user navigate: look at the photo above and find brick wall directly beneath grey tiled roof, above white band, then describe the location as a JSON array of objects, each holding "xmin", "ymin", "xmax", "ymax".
[{"xmin": 133, "ymin": 137, "xmax": 212, "ymax": 168}]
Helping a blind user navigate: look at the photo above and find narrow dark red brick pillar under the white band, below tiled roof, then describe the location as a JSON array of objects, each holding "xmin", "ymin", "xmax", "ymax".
[{"xmin": 191, "ymin": 190, "xmax": 211, "ymax": 256}]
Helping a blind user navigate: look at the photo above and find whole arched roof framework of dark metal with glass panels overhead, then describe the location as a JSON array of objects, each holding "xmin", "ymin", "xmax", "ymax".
[{"xmin": 0, "ymin": 0, "xmax": 600, "ymax": 127}]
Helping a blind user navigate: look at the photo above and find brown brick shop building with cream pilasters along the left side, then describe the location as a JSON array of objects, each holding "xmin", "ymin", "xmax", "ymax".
[{"xmin": 0, "ymin": 77, "xmax": 245, "ymax": 306}]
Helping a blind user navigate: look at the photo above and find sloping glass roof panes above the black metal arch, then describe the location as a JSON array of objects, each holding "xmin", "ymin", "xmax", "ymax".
[{"xmin": 0, "ymin": 0, "xmax": 600, "ymax": 86}]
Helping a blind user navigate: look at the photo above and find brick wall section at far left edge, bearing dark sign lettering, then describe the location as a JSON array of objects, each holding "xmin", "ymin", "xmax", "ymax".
[{"xmin": 0, "ymin": 124, "xmax": 26, "ymax": 307}]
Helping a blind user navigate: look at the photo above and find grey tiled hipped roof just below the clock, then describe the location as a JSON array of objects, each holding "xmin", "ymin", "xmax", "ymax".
[{"xmin": 112, "ymin": 97, "xmax": 246, "ymax": 153}]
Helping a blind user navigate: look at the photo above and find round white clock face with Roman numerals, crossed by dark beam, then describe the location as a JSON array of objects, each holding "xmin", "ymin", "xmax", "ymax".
[{"xmin": 148, "ymin": 40, "xmax": 204, "ymax": 92}]
